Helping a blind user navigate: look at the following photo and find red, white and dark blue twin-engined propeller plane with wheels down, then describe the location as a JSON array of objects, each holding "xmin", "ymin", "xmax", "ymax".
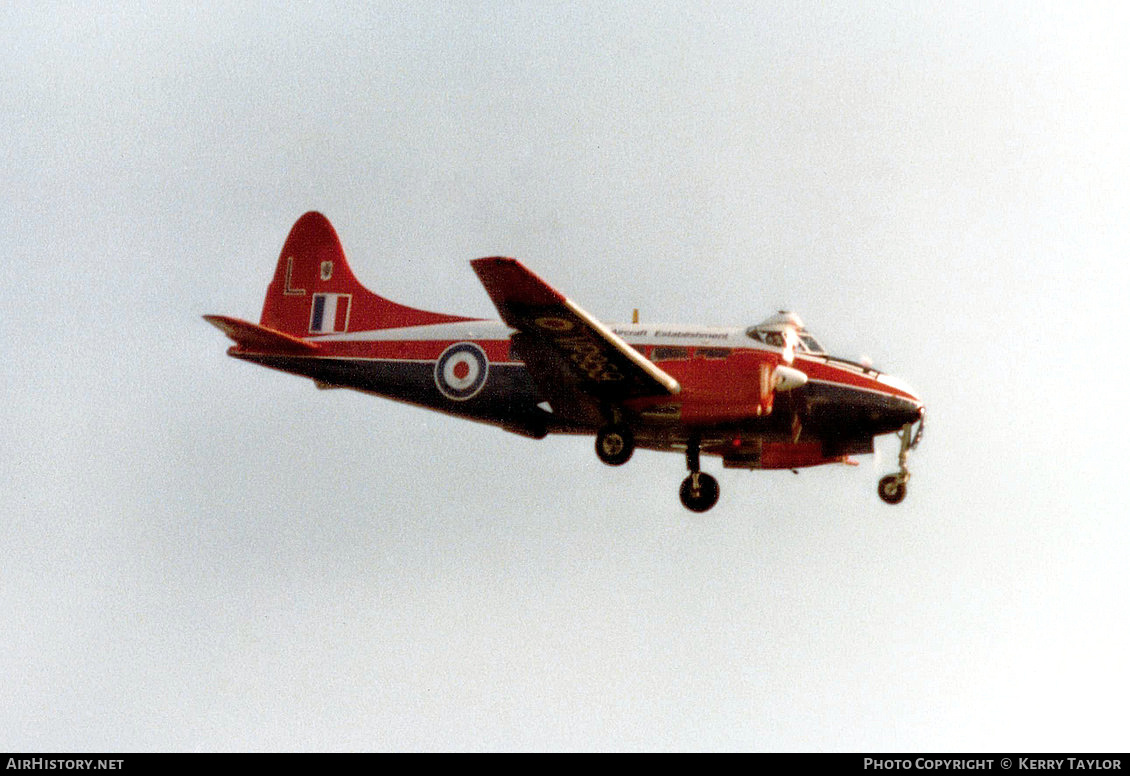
[{"xmin": 203, "ymin": 211, "xmax": 925, "ymax": 513}]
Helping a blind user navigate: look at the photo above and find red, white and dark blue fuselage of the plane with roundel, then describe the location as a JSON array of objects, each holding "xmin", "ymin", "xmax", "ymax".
[{"xmin": 228, "ymin": 321, "xmax": 922, "ymax": 469}]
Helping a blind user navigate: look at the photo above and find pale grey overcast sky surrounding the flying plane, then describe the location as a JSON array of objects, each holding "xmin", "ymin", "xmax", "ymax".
[{"xmin": 0, "ymin": 0, "xmax": 1130, "ymax": 752}]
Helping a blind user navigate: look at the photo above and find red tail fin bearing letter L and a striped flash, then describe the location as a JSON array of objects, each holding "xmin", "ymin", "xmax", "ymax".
[{"xmin": 259, "ymin": 212, "xmax": 472, "ymax": 337}]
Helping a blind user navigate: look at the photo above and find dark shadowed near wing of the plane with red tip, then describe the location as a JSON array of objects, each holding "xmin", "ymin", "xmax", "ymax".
[{"xmin": 471, "ymin": 258, "xmax": 680, "ymax": 402}]
